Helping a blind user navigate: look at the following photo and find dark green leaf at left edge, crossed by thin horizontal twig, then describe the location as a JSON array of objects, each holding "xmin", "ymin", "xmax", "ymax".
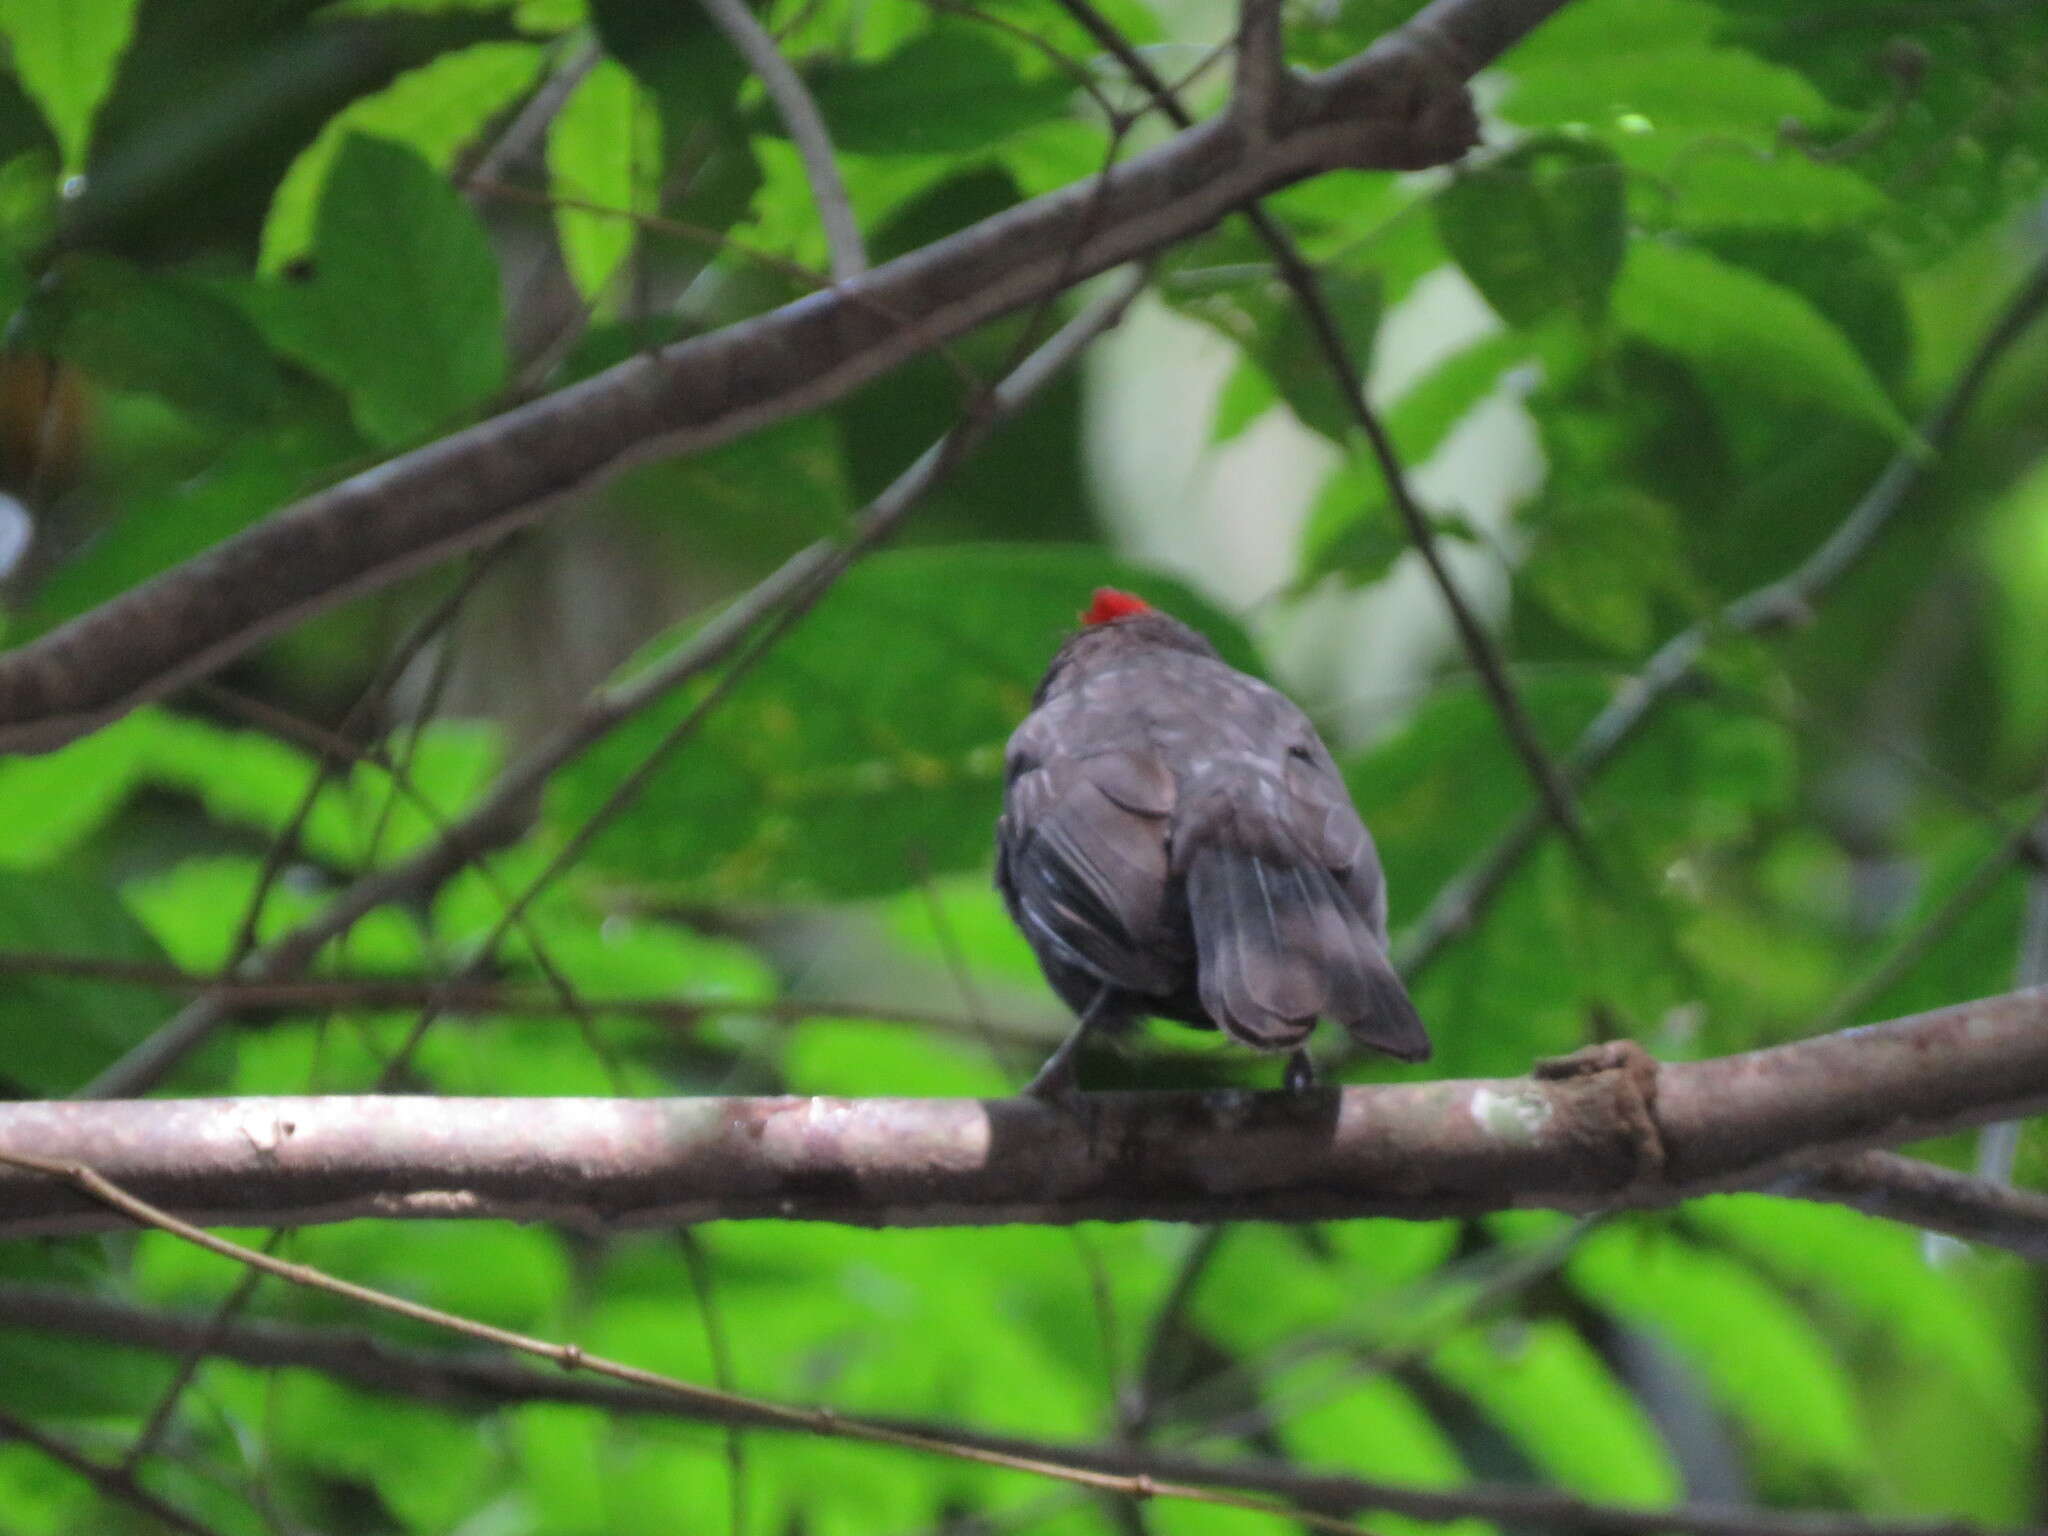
[{"xmin": 0, "ymin": 870, "xmax": 168, "ymax": 1096}]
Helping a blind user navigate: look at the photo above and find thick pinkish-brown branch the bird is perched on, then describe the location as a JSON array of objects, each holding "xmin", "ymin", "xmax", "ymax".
[{"xmin": 0, "ymin": 989, "xmax": 2048, "ymax": 1237}]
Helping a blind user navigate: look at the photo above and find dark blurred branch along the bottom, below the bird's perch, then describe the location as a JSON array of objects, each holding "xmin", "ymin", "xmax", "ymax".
[{"xmin": 0, "ymin": 1282, "xmax": 1998, "ymax": 1536}]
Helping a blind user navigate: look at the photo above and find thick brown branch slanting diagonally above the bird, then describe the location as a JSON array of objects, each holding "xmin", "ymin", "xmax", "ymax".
[{"xmin": 0, "ymin": 0, "xmax": 1523, "ymax": 752}]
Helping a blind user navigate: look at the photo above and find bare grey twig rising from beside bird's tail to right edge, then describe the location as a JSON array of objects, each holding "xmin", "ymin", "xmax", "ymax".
[{"xmin": 1397, "ymin": 246, "xmax": 2048, "ymax": 977}]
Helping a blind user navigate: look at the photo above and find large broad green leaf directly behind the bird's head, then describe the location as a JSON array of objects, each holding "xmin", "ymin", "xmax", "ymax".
[{"xmin": 549, "ymin": 547, "xmax": 1255, "ymax": 901}]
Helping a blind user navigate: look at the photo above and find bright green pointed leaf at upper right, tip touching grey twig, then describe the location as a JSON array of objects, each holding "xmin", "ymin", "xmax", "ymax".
[{"xmin": 1614, "ymin": 242, "xmax": 1917, "ymax": 442}]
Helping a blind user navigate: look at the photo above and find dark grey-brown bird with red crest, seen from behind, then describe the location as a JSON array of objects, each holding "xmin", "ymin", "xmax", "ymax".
[{"xmin": 995, "ymin": 588, "xmax": 1430, "ymax": 1100}]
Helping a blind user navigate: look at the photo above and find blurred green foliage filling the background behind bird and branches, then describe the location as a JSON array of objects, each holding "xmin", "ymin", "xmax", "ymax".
[{"xmin": 0, "ymin": 0, "xmax": 2048, "ymax": 1536}]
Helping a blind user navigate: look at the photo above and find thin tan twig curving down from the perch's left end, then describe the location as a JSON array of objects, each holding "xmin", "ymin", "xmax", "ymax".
[{"xmin": 0, "ymin": 1151, "xmax": 1392, "ymax": 1536}]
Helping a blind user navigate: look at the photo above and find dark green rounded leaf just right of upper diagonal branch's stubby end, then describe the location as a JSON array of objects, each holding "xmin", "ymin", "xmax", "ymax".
[{"xmin": 1432, "ymin": 135, "xmax": 1628, "ymax": 326}]
